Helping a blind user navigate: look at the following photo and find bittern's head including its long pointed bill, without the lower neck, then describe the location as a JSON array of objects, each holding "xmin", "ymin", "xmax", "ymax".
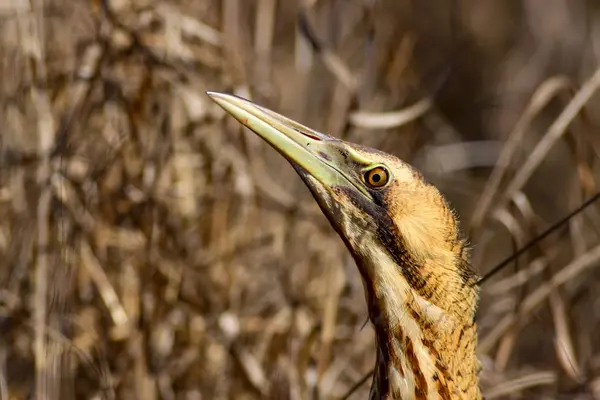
[{"xmin": 208, "ymin": 92, "xmax": 477, "ymax": 321}]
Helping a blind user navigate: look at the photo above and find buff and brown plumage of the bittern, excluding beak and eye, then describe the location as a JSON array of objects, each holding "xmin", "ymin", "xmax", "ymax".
[{"xmin": 301, "ymin": 142, "xmax": 481, "ymax": 400}]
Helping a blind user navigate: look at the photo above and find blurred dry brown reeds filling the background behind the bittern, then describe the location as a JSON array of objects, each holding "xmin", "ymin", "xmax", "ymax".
[{"xmin": 0, "ymin": 0, "xmax": 600, "ymax": 400}]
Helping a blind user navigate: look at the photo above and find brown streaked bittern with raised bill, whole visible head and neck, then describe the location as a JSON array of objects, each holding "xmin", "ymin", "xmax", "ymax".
[{"xmin": 207, "ymin": 92, "xmax": 481, "ymax": 400}]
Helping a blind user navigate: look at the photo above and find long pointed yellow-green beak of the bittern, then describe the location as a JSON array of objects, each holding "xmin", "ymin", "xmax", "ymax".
[{"xmin": 206, "ymin": 92, "xmax": 368, "ymax": 195}]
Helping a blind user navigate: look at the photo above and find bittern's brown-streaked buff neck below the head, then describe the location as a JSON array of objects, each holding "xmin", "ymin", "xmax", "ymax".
[{"xmin": 355, "ymin": 242, "xmax": 481, "ymax": 399}]
